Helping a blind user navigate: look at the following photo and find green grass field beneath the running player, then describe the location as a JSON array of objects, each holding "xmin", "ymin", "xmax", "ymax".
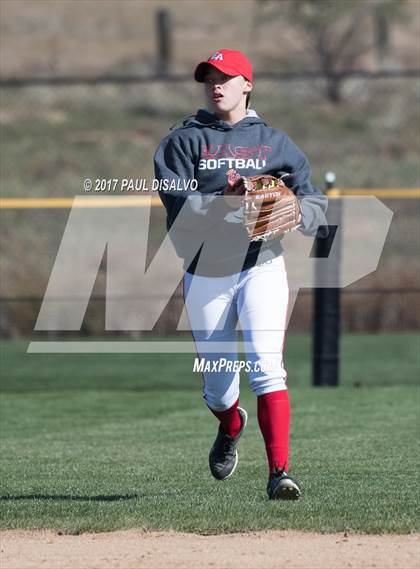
[{"xmin": 0, "ymin": 333, "xmax": 420, "ymax": 533}]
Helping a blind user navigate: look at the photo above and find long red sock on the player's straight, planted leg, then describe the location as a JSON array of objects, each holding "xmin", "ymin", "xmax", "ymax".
[{"xmin": 257, "ymin": 389, "xmax": 290, "ymax": 476}]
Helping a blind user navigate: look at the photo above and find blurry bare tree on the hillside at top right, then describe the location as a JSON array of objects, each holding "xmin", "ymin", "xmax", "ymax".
[{"xmin": 256, "ymin": 0, "xmax": 404, "ymax": 104}]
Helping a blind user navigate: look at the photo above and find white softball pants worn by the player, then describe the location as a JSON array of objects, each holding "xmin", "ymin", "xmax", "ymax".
[{"xmin": 184, "ymin": 256, "xmax": 289, "ymax": 411}]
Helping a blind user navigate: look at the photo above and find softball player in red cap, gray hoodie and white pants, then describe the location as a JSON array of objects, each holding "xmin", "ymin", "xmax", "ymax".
[{"xmin": 155, "ymin": 49, "xmax": 326, "ymax": 500}]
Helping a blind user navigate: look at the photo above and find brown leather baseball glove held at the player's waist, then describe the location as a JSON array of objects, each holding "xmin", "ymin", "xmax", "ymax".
[{"xmin": 228, "ymin": 172, "xmax": 301, "ymax": 241}]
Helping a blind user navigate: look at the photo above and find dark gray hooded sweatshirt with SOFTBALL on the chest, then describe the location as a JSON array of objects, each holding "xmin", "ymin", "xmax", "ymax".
[{"xmin": 154, "ymin": 109, "xmax": 327, "ymax": 276}]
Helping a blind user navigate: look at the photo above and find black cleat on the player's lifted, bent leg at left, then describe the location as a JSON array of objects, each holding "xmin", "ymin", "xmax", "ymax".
[{"xmin": 209, "ymin": 407, "xmax": 248, "ymax": 480}]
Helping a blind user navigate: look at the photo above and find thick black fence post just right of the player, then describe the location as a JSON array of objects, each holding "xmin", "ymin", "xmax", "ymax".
[{"xmin": 312, "ymin": 172, "xmax": 340, "ymax": 386}]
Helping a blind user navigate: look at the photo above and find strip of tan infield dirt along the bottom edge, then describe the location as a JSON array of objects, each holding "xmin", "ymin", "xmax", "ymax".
[{"xmin": 0, "ymin": 530, "xmax": 420, "ymax": 569}]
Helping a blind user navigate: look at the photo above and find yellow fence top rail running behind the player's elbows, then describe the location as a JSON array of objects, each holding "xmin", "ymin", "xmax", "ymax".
[{"xmin": 0, "ymin": 188, "xmax": 420, "ymax": 209}]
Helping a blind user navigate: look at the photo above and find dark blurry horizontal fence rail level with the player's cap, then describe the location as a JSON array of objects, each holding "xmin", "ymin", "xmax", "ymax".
[{"xmin": 0, "ymin": 69, "xmax": 420, "ymax": 87}]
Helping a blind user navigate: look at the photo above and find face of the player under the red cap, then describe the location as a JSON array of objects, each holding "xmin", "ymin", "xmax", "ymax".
[{"xmin": 204, "ymin": 67, "xmax": 252, "ymax": 115}]
